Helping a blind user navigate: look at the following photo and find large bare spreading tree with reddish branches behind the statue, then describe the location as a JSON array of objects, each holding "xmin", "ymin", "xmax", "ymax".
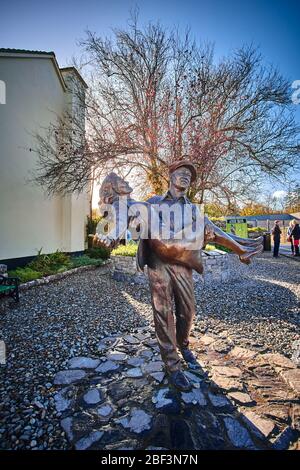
[{"xmin": 31, "ymin": 17, "xmax": 300, "ymax": 206}]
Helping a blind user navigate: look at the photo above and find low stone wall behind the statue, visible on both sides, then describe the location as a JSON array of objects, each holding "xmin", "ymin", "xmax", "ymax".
[{"xmin": 111, "ymin": 250, "xmax": 232, "ymax": 284}]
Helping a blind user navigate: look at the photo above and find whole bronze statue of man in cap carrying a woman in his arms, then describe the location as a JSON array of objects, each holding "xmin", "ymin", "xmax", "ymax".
[{"xmin": 94, "ymin": 159, "xmax": 263, "ymax": 391}]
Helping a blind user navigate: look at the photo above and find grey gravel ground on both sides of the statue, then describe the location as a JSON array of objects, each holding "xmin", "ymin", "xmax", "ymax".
[{"xmin": 0, "ymin": 254, "xmax": 300, "ymax": 449}]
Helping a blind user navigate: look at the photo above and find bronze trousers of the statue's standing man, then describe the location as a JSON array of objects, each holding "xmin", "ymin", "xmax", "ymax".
[{"xmin": 148, "ymin": 257, "xmax": 196, "ymax": 372}]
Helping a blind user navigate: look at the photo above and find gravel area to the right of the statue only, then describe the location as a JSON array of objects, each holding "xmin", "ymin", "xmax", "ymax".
[{"xmin": 196, "ymin": 254, "xmax": 300, "ymax": 357}]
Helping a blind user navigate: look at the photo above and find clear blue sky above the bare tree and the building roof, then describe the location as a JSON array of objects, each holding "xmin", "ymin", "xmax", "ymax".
[{"xmin": 0, "ymin": 0, "xmax": 300, "ymax": 200}]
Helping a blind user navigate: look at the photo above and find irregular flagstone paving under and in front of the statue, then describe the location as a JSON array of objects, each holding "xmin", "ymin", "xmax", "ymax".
[{"xmin": 54, "ymin": 328, "xmax": 300, "ymax": 450}]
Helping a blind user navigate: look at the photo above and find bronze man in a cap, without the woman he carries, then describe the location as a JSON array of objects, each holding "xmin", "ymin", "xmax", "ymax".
[{"xmin": 138, "ymin": 160, "xmax": 197, "ymax": 391}]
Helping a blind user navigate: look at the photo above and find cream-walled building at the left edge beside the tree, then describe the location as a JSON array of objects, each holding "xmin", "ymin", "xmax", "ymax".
[{"xmin": 0, "ymin": 49, "xmax": 88, "ymax": 267}]
